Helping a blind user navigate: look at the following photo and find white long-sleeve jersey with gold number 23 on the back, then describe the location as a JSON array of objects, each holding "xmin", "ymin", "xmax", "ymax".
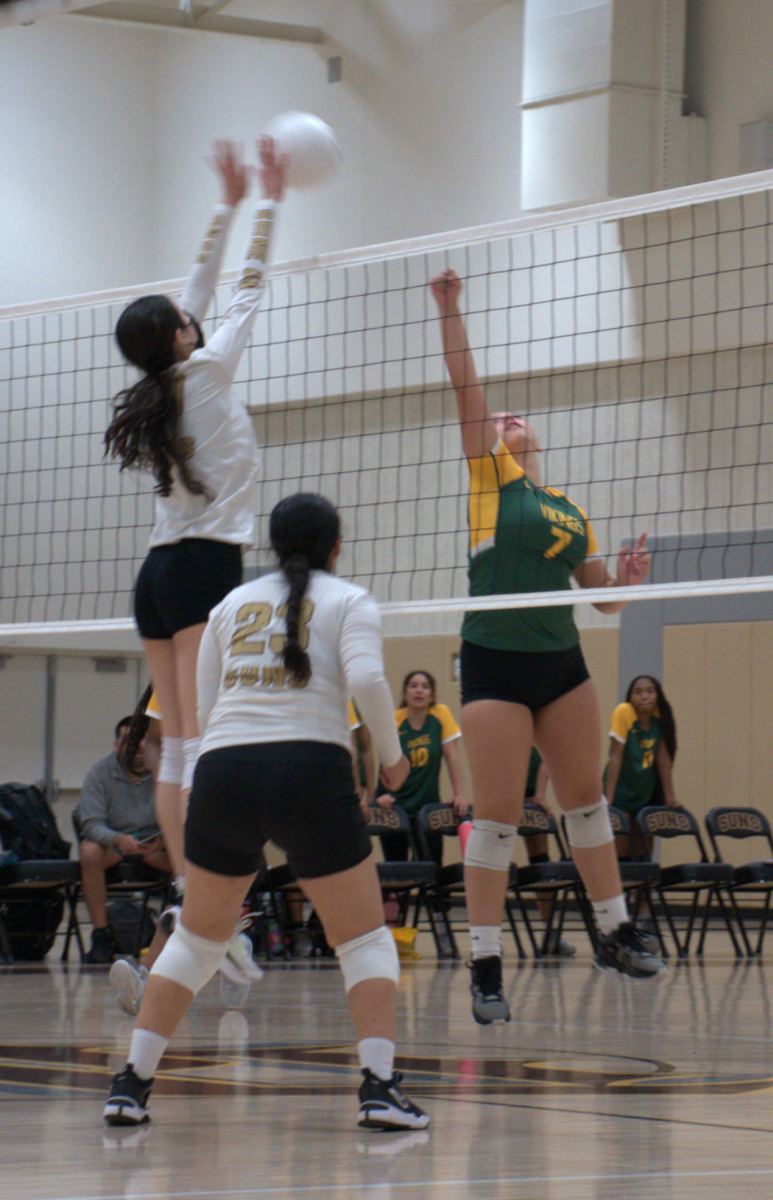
[{"xmin": 197, "ymin": 571, "xmax": 401, "ymax": 767}]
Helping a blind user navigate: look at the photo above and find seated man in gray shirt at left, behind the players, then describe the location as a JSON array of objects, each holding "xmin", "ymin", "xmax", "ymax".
[{"xmin": 77, "ymin": 716, "xmax": 172, "ymax": 962}]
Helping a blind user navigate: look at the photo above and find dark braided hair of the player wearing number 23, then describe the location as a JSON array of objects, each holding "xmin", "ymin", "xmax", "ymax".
[{"xmin": 269, "ymin": 492, "xmax": 341, "ymax": 688}]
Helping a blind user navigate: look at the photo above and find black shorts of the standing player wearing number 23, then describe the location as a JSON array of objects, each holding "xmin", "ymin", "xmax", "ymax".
[{"xmin": 185, "ymin": 742, "xmax": 371, "ymax": 880}]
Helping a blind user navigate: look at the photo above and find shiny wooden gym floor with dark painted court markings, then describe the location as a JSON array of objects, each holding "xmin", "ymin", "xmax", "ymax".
[{"xmin": 0, "ymin": 932, "xmax": 773, "ymax": 1200}]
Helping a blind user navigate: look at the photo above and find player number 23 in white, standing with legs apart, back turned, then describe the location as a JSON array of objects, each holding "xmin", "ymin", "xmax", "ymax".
[{"xmin": 104, "ymin": 493, "xmax": 429, "ymax": 1129}]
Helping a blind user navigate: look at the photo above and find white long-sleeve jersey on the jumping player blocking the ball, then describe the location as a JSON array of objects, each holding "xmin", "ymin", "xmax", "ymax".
[{"xmin": 150, "ymin": 200, "xmax": 276, "ymax": 547}]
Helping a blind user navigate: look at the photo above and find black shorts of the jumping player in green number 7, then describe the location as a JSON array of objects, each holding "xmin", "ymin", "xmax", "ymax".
[{"xmin": 461, "ymin": 641, "xmax": 591, "ymax": 713}]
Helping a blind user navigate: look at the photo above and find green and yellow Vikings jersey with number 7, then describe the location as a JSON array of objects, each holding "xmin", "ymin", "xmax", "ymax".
[{"xmin": 462, "ymin": 440, "xmax": 599, "ymax": 650}]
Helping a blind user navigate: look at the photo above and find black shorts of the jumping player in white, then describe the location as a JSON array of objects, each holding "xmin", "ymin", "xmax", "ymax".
[{"xmin": 134, "ymin": 538, "xmax": 241, "ymax": 640}]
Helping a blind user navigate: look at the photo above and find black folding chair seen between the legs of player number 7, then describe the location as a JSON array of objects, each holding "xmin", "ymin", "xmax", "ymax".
[{"xmin": 508, "ymin": 800, "xmax": 597, "ymax": 959}]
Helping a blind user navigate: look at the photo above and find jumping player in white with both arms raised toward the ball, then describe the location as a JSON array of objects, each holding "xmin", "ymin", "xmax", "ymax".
[{"xmin": 104, "ymin": 138, "xmax": 287, "ymax": 974}]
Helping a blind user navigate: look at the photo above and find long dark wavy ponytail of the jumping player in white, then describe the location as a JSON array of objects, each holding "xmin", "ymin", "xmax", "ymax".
[{"xmin": 104, "ymin": 295, "xmax": 212, "ymax": 499}]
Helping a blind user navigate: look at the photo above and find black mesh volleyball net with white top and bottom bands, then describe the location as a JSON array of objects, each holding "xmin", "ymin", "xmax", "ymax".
[{"xmin": 0, "ymin": 173, "xmax": 773, "ymax": 643}]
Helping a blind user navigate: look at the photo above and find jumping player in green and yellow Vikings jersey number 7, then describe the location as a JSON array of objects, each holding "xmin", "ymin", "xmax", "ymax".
[{"xmin": 431, "ymin": 270, "xmax": 664, "ymax": 1024}]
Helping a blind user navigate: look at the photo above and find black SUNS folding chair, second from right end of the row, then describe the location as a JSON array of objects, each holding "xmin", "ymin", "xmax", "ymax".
[{"xmin": 636, "ymin": 805, "xmax": 743, "ymax": 959}]
